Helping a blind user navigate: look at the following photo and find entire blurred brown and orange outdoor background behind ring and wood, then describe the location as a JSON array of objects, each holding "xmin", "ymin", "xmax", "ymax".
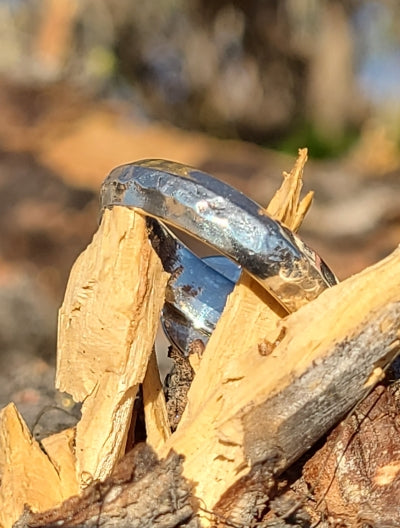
[{"xmin": 0, "ymin": 0, "xmax": 400, "ymax": 425}]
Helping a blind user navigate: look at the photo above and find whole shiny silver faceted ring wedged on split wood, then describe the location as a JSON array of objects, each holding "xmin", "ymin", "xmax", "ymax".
[{"xmin": 100, "ymin": 159, "xmax": 337, "ymax": 353}]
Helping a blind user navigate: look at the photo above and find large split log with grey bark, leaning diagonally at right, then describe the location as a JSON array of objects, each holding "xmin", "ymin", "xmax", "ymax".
[{"xmin": 164, "ymin": 248, "xmax": 400, "ymax": 525}]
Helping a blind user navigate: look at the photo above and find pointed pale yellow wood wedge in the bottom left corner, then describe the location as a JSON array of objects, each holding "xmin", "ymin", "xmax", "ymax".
[{"xmin": 0, "ymin": 403, "xmax": 69, "ymax": 528}]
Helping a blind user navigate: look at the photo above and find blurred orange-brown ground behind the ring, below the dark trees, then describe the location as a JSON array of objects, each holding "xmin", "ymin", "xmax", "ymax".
[{"xmin": 0, "ymin": 80, "xmax": 400, "ymax": 434}]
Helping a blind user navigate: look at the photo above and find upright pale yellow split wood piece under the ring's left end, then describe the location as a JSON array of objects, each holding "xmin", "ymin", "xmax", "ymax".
[{"xmin": 56, "ymin": 207, "xmax": 168, "ymax": 486}]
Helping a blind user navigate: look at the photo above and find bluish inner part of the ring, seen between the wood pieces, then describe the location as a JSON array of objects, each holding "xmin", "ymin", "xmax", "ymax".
[{"xmin": 147, "ymin": 218, "xmax": 240, "ymax": 354}]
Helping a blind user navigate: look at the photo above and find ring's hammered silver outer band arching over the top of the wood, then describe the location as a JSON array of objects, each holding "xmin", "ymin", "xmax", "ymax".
[{"xmin": 101, "ymin": 155, "xmax": 337, "ymax": 318}]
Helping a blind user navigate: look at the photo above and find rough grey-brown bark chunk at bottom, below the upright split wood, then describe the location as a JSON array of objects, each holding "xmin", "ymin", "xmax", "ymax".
[{"xmin": 14, "ymin": 444, "xmax": 199, "ymax": 528}]
